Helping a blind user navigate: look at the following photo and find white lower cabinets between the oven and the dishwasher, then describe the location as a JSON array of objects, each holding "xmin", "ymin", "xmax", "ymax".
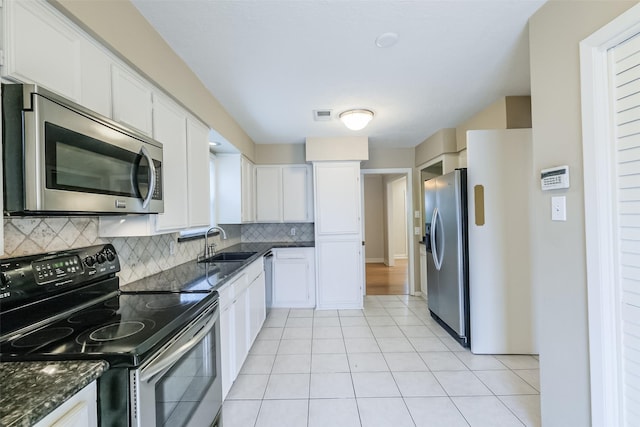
[{"xmin": 219, "ymin": 258, "xmax": 266, "ymax": 398}]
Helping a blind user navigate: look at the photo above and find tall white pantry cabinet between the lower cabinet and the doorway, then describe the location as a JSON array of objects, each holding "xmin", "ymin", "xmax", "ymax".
[{"xmin": 313, "ymin": 161, "xmax": 363, "ymax": 309}]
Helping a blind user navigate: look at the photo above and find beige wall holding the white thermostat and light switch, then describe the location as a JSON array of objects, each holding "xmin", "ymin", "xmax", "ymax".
[{"xmin": 529, "ymin": 1, "xmax": 636, "ymax": 427}]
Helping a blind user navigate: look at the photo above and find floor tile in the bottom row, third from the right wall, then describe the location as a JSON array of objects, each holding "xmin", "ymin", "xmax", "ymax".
[{"xmin": 404, "ymin": 397, "xmax": 469, "ymax": 427}]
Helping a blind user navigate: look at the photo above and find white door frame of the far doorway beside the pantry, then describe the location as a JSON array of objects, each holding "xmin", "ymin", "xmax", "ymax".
[{"xmin": 360, "ymin": 168, "xmax": 416, "ymax": 295}]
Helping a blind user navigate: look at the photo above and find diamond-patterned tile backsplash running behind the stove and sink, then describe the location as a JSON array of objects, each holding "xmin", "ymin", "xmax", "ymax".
[{"xmin": 2, "ymin": 217, "xmax": 314, "ymax": 285}]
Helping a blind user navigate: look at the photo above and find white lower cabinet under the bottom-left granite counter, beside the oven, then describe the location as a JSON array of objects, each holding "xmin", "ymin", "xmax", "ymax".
[{"xmin": 34, "ymin": 381, "xmax": 98, "ymax": 427}]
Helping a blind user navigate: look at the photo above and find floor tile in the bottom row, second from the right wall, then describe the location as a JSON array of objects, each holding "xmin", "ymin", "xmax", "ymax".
[{"xmin": 452, "ymin": 396, "xmax": 522, "ymax": 427}]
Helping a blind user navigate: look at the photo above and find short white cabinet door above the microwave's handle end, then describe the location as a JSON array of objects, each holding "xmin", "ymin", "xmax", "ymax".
[{"xmin": 111, "ymin": 65, "xmax": 153, "ymax": 135}]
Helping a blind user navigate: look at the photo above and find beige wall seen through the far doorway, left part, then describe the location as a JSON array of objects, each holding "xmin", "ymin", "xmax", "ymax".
[{"xmin": 364, "ymin": 174, "xmax": 385, "ymax": 262}]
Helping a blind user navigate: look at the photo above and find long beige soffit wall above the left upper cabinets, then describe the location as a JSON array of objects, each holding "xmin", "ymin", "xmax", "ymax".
[{"xmin": 49, "ymin": 0, "xmax": 255, "ymax": 160}]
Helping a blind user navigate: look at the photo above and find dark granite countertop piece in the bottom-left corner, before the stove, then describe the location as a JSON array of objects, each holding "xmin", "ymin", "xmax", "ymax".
[{"xmin": 0, "ymin": 360, "xmax": 109, "ymax": 427}]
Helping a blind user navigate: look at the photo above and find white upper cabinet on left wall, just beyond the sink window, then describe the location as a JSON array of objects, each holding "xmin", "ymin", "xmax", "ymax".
[{"xmin": 216, "ymin": 154, "xmax": 255, "ymax": 224}]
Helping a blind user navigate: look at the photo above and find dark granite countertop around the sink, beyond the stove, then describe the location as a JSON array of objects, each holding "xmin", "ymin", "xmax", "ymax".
[{"xmin": 121, "ymin": 242, "xmax": 315, "ymax": 292}]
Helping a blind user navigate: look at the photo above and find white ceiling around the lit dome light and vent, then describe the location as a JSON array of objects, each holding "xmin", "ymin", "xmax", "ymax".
[{"xmin": 132, "ymin": 0, "xmax": 544, "ymax": 147}]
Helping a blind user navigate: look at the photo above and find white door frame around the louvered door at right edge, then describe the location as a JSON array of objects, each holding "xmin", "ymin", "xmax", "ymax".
[{"xmin": 580, "ymin": 5, "xmax": 640, "ymax": 426}]
